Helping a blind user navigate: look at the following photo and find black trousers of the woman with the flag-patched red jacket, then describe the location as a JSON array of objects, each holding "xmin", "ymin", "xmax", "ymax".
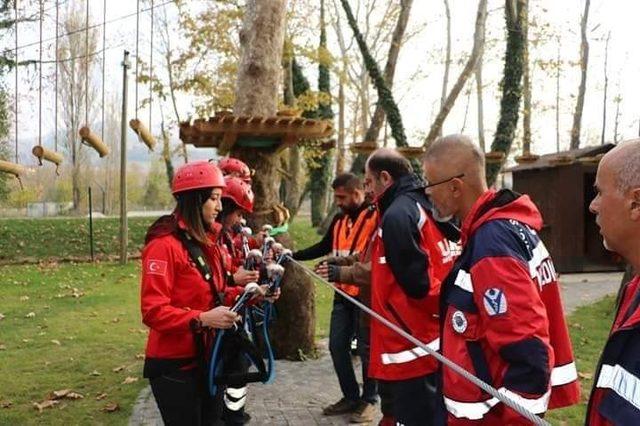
[{"xmin": 149, "ymin": 369, "xmax": 222, "ymax": 426}]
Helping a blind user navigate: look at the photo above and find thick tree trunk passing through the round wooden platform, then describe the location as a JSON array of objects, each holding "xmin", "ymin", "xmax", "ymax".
[{"xmin": 231, "ymin": 0, "xmax": 315, "ymax": 358}]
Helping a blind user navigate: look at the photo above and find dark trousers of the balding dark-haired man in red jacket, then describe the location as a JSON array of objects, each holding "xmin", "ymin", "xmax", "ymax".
[{"xmin": 385, "ymin": 374, "xmax": 443, "ymax": 426}]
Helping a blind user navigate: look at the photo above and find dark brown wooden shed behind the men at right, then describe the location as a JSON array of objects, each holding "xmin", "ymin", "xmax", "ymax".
[{"xmin": 506, "ymin": 144, "xmax": 624, "ymax": 272}]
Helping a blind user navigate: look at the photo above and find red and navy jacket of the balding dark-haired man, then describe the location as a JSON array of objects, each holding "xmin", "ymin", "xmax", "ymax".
[{"xmin": 369, "ymin": 176, "xmax": 456, "ymax": 381}]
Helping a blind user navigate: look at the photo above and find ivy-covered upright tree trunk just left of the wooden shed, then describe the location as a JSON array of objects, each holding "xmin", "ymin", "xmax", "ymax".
[{"xmin": 487, "ymin": 0, "xmax": 528, "ymax": 186}]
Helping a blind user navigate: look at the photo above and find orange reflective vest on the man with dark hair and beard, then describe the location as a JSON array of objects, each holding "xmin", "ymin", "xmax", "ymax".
[{"xmin": 333, "ymin": 205, "xmax": 378, "ymax": 297}]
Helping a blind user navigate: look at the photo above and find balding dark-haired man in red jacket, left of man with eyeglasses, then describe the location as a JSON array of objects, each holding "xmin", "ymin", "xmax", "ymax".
[{"xmin": 365, "ymin": 149, "xmax": 457, "ymax": 426}]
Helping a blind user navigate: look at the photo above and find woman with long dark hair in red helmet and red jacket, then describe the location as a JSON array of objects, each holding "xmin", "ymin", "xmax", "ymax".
[{"xmin": 141, "ymin": 161, "xmax": 241, "ymax": 425}]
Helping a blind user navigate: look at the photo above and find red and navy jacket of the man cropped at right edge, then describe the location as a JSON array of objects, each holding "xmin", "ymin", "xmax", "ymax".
[{"xmin": 586, "ymin": 275, "xmax": 640, "ymax": 426}]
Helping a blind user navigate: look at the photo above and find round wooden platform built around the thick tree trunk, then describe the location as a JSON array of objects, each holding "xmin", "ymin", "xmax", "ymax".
[{"xmin": 180, "ymin": 111, "xmax": 333, "ymax": 155}]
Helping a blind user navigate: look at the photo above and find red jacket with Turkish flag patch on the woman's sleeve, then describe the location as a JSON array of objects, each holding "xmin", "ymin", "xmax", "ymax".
[{"xmin": 140, "ymin": 216, "xmax": 239, "ymax": 359}]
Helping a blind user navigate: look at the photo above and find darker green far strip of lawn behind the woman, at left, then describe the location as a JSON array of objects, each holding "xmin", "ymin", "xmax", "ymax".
[{"xmin": 0, "ymin": 217, "xmax": 155, "ymax": 264}]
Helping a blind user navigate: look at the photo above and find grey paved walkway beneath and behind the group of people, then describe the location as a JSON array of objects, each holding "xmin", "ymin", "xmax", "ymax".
[{"xmin": 129, "ymin": 273, "xmax": 622, "ymax": 426}]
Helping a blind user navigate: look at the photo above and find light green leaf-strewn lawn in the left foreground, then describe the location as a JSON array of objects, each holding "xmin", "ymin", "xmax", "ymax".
[{"xmin": 0, "ymin": 263, "xmax": 147, "ymax": 425}]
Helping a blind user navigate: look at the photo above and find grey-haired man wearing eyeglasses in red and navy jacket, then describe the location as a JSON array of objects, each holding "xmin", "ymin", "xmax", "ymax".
[{"xmin": 423, "ymin": 135, "xmax": 579, "ymax": 425}]
